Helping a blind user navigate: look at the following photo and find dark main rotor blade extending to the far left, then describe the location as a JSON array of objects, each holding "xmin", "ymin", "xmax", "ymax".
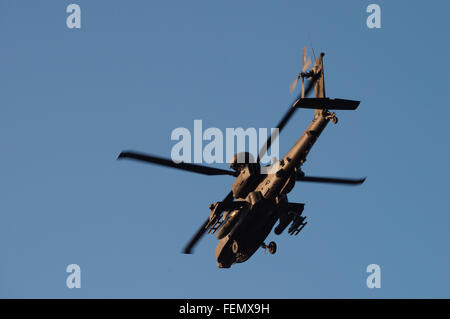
[{"xmin": 117, "ymin": 151, "xmax": 237, "ymax": 176}]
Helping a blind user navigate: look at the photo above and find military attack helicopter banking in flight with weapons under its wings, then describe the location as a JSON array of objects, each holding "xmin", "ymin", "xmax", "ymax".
[{"xmin": 117, "ymin": 47, "xmax": 366, "ymax": 268}]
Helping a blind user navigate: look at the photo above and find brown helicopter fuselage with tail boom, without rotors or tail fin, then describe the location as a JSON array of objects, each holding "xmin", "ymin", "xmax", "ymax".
[{"xmin": 216, "ymin": 110, "xmax": 330, "ymax": 268}]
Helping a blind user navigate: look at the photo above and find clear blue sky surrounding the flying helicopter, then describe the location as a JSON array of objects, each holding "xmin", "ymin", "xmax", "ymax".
[{"xmin": 0, "ymin": 0, "xmax": 450, "ymax": 298}]
